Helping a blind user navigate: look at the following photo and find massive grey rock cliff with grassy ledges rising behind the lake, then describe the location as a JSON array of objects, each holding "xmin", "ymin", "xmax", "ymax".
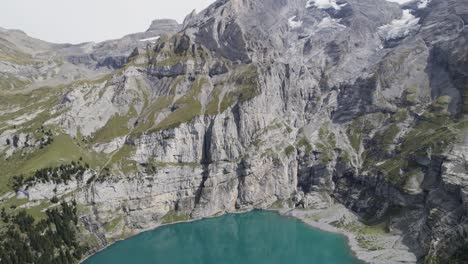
[{"xmin": 0, "ymin": 0, "xmax": 468, "ymax": 263}]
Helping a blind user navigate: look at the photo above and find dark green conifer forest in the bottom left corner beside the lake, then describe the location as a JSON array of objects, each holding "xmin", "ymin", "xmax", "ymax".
[{"xmin": 0, "ymin": 202, "xmax": 86, "ymax": 264}]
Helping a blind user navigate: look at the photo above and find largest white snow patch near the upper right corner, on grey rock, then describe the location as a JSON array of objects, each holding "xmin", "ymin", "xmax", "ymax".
[{"xmin": 379, "ymin": 10, "xmax": 419, "ymax": 40}]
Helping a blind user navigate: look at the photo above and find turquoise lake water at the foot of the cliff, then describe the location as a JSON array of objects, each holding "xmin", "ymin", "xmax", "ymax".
[{"xmin": 84, "ymin": 211, "xmax": 360, "ymax": 264}]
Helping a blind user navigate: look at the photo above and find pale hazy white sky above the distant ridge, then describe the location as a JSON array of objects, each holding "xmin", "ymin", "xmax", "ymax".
[{"xmin": 0, "ymin": 0, "xmax": 214, "ymax": 43}]
